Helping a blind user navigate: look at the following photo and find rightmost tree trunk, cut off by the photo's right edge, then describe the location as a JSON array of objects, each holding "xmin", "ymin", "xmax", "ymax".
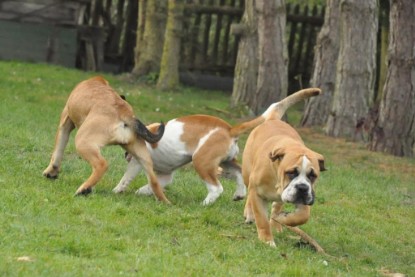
[{"xmin": 369, "ymin": 0, "xmax": 415, "ymax": 157}]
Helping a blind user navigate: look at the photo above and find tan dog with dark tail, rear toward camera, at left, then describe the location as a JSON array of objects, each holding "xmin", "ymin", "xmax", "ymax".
[{"xmin": 43, "ymin": 77, "xmax": 169, "ymax": 203}]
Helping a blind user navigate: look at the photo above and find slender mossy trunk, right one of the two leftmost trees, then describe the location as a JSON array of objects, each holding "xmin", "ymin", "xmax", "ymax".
[{"xmin": 157, "ymin": 0, "xmax": 184, "ymax": 90}]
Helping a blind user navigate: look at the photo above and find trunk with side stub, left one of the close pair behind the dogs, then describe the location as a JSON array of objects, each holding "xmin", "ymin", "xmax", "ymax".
[{"xmin": 231, "ymin": 0, "xmax": 258, "ymax": 110}]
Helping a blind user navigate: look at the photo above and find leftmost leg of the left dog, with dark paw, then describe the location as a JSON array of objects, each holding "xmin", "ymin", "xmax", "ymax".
[{"xmin": 43, "ymin": 107, "xmax": 75, "ymax": 179}]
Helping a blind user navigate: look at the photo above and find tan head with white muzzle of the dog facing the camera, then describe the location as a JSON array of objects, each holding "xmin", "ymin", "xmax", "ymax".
[{"xmin": 269, "ymin": 146, "xmax": 326, "ymax": 205}]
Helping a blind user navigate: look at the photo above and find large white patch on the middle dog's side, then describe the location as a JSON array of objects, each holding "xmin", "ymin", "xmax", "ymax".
[{"xmin": 146, "ymin": 119, "xmax": 191, "ymax": 173}]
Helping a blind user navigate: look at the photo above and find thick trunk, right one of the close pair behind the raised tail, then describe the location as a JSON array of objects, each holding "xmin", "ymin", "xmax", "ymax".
[{"xmin": 254, "ymin": 0, "xmax": 288, "ymax": 114}]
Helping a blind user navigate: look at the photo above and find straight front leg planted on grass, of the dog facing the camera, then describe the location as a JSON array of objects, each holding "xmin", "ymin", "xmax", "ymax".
[{"xmin": 249, "ymin": 185, "xmax": 275, "ymax": 247}]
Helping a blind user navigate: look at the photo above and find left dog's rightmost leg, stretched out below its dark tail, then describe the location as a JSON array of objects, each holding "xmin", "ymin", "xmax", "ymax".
[{"xmin": 124, "ymin": 139, "xmax": 170, "ymax": 204}]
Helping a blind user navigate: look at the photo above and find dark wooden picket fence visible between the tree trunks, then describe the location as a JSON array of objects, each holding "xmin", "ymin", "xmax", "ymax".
[{"xmin": 89, "ymin": 0, "xmax": 324, "ymax": 91}]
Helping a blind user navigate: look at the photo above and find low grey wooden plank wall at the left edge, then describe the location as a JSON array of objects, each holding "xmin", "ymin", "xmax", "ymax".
[{"xmin": 0, "ymin": 20, "xmax": 77, "ymax": 67}]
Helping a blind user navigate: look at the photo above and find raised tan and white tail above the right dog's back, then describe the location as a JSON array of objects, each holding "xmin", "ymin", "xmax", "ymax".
[{"xmin": 231, "ymin": 88, "xmax": 322, "ymax": 137}]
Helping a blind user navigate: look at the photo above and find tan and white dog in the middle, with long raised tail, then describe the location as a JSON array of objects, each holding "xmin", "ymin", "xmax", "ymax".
[{"xmin": 113, "ymin": 89, "xmax": 319, "ymax": 205}]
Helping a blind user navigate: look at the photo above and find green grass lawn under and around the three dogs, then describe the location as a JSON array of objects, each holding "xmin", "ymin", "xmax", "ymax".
[{"xmin": 0, "ymin": 62, "xmax": 415, "ymax": 276}]
